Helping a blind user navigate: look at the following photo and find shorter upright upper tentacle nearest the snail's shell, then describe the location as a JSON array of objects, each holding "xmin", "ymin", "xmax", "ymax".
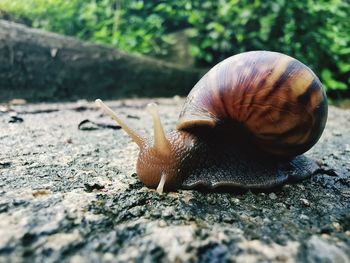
[{"xmin": 146, "ymin": 103, "xmax": 171, "ymax": 156}]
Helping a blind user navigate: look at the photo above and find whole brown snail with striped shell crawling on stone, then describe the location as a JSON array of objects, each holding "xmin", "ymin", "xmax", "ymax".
[{"xmin": 96, "ymin": 51, "xmax": 328, "ymax": 193}]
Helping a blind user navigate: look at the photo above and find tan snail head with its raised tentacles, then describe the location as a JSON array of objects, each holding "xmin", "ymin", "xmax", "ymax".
[{"xmin": 95, "ymin": 99, "xmax": 184, "ymax": 193}]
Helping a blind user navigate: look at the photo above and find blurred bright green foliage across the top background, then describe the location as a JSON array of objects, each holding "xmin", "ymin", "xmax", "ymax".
[{"xmin": 0, "ymin": 0, "xmax": 350, "ymax": 95}]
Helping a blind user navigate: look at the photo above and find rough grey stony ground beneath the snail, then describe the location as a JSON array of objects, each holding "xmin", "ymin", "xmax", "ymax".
[{"xmin": 0, "ymin": 98, "xmax": 350, "ymax": 262}]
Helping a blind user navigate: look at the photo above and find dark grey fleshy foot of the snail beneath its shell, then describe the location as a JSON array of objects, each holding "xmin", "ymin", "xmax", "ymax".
[{"xmin": 182, "ymin": 140, "xmax": 320, "ymax": 189}]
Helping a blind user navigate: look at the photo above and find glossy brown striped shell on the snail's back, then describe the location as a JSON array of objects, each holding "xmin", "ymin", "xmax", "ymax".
[{"xmin": 177, "ymin": 51, "xmax": 327, "ymax": 156}]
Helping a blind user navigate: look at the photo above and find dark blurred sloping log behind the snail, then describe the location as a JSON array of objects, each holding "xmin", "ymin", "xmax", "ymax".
[{"xmin": 0, "ymin": 20, "xmax": 203, "ymax": 101}]
